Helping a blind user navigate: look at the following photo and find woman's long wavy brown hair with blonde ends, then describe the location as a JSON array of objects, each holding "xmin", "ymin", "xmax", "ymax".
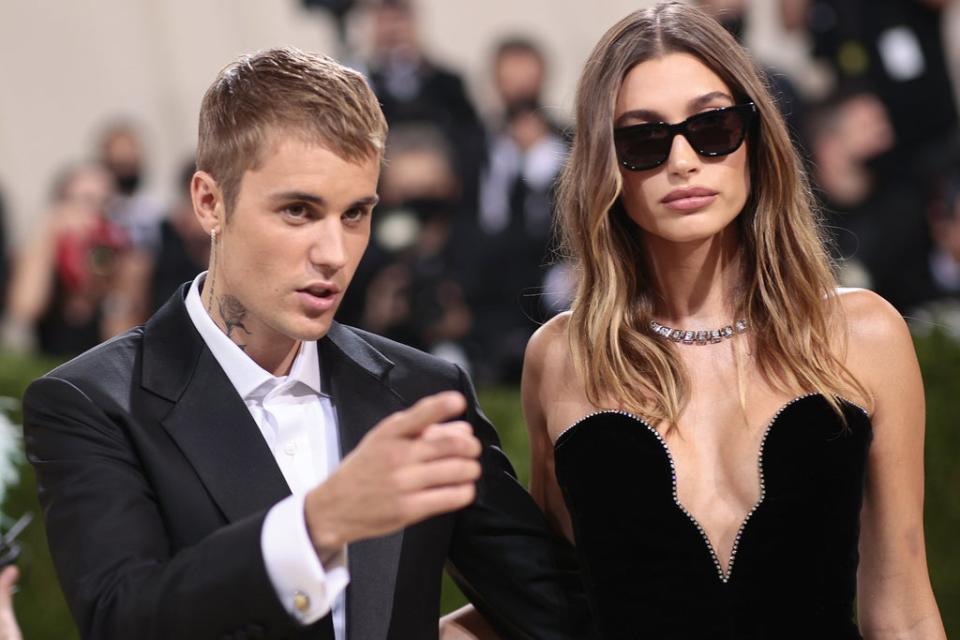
[{"xmin": 558, "ymin": 3, "xmax": 870, "ymax": 427}]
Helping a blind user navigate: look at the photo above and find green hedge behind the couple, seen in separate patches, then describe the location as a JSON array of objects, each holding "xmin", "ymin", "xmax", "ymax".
[{"xmin": 0, "ymin": 334, "xmax": 960, "ymax": 640}]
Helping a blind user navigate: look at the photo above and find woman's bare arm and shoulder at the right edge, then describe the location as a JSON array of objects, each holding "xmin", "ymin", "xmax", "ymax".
[{"xmin": 841, "ymin": 291, "xmax": 946, "ymax": 640}]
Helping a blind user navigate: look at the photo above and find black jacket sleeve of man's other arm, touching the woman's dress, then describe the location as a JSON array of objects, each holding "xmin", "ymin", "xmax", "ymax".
[{"xmin": 450, "ymin": 364, "xmax": 592, "ymax": 640}]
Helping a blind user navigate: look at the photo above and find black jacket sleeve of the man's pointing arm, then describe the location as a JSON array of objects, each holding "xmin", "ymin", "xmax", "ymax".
[{"xmin": 24, "ymin": 376, "xmax": 312, "ymax": 640}]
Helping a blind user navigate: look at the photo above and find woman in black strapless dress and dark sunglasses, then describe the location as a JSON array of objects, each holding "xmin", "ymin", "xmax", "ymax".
[{"xmin": 523, "ymin": 3, "xmax": 944, "ymax": 639}]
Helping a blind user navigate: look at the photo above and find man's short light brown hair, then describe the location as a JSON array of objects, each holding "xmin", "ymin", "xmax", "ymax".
[{"xmin": 197, "ymin": 47, "xmax": 387, "ymax": 214}]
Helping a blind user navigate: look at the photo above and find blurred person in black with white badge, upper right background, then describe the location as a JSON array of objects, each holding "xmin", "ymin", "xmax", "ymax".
[{"xmin": 780, "ymin": 0, "xmax": 960, "ymax": 312}]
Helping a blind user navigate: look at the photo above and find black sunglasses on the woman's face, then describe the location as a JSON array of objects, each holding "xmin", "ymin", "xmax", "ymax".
[{"xmin": 613, "ymin": 102, "xmax": 757, "ymax": 171}]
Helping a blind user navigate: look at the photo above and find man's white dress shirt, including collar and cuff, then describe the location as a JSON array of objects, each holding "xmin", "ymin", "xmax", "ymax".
[{"xmin": 186, "ymin": 272, "xmax": 350, "ymax": 640}]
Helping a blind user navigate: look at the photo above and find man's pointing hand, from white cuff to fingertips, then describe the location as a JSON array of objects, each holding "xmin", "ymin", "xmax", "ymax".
[{"xmin": 304, "ymin": 391, "xmax": 481, "ymax": 555}]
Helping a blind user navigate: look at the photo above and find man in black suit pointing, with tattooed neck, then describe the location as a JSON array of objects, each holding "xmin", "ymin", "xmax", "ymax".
[{"xmin": 24, "ymin": 49, "xmax": 577, "ymax": 640}]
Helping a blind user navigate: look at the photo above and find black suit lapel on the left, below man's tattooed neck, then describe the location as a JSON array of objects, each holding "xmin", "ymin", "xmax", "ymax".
[{"xmin": 143, "ymin": 289, "xmax": 290, "ymax": 522}]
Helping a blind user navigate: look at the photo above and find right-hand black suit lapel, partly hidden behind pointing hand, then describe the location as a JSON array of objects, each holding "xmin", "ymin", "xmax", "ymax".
[{"xmin": 320, "ymin": 323, "xmax": 407, "ymax": 638}]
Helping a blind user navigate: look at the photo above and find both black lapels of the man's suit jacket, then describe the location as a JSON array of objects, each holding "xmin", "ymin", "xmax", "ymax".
[{"xmin": 142, "ymin": 288, "xmax": 408, "ymax": 638}]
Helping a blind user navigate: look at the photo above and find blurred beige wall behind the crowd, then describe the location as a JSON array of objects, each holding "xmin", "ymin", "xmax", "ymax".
[{"xmin": 0, "ymin": 0, "xmax": 960, "ymax": 243}]
